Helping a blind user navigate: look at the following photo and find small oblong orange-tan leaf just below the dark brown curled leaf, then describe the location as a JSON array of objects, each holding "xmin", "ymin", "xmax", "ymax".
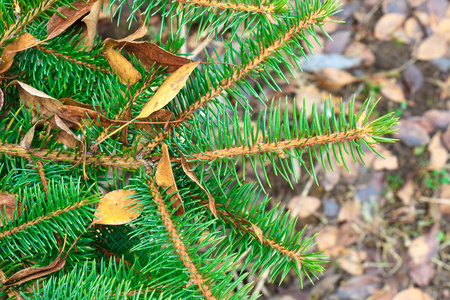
[{"xmin": 104, "ymin": 47, "xmax": 142, "ymax": 85}]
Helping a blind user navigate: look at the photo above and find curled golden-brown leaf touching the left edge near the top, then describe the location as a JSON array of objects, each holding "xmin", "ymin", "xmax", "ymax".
[{"xmin": 0, "ymin": 32, "xmax": 42, "ymax": 74}]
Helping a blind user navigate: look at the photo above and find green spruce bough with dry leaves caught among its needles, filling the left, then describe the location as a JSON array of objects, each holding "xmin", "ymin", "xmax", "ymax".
[{"xmin": 0, "ymin": 0, "xmax": 396, "ymax": 299}]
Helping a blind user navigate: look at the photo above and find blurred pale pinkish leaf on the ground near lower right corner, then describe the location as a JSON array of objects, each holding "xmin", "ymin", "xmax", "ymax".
[{"xmin": 408, "ymin": 223, "xmax": 439, "ymax": 286}]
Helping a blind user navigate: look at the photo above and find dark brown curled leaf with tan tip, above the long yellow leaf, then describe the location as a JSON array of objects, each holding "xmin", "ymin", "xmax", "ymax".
[{"xmin": 103, "ymin": 26, "xmax": 191, "ymax": 73}]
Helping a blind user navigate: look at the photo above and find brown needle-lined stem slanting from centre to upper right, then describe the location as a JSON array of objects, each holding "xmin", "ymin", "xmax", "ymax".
[{"xmin": 145, "ymin": 12, "xmax": 323, "ymax": 150}]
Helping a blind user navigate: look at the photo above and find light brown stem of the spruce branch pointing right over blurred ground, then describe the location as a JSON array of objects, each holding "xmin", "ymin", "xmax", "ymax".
[{"xmin": 191, "ymin": 126, "xmax": 370, "ymax": 161}]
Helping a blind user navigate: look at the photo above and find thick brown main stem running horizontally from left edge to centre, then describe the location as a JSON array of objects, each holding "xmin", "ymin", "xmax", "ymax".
[{"xmin": 0, "ymin": 143, "xmax": 148, "ymax": 169}]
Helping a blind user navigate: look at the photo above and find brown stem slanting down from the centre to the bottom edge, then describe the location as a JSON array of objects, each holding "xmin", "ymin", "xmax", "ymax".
[{"xmin": 148, "ymin": 180, "xmax": 217, "ymax": 300}]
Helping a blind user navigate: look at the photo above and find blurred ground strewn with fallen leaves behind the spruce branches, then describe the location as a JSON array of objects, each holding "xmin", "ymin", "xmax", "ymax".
[{"xmin": 99, "ymin": 0, "xmax": 450, "ymax": 300}]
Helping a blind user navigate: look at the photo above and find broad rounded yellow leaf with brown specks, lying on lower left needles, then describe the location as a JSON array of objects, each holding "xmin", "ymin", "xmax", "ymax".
[{"xmin": 93, "ymin": 190, "xmax": 141, "ymax": 225}]
